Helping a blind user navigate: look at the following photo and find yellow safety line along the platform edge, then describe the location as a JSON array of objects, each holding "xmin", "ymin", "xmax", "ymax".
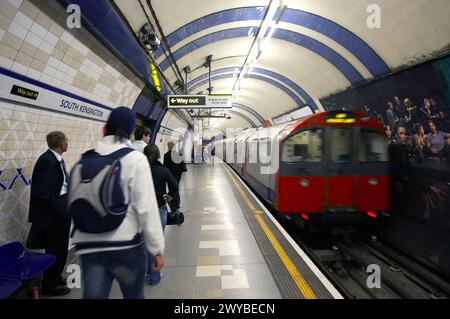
[{"xmin": 225, "ymin": 168, "xmax": 317, "ymax": 299}]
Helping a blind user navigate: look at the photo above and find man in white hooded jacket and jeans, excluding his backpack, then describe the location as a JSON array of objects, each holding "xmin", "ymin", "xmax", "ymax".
[{"xmin": 69, "ymin": 107, "xmax": 164, "ymax": 299}]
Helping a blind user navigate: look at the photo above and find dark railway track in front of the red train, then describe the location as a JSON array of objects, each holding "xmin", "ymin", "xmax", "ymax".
[{"xmin": 293, "ymin": 228, "xmax": 450, "ymax": 299}]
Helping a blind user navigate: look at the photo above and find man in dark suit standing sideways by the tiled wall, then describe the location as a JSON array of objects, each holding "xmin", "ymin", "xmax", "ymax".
[{"xmin": 27, "ymin": 131, "xmax": 70, "ymax": 296}]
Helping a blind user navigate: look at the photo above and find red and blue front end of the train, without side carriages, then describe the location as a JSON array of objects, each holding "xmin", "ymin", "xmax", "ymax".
[{"xmin": 274, "ymin": 112, "xmax": 390, "ymax": 223}]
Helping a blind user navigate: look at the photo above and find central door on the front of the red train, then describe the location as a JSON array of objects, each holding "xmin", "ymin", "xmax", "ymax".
[{"xmin": 324, "ymin": 126, "xmax": 356, "ymax": 211}]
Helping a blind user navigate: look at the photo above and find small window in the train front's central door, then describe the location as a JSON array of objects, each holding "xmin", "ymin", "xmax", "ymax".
[{"xmin": 330, "ymin": 127, "xmax": 352, "ymax": 163}]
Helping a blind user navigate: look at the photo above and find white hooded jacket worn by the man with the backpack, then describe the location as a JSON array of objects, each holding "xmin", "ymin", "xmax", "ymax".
[{"xmin": 72, "ymin": 136, "xmax": 164, "ymax": 256}]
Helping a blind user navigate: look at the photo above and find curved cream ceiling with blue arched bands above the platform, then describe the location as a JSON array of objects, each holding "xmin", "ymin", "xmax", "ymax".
[{"xmin": 115, "ymin": 0, "xmax": 450, "ymax": 128}]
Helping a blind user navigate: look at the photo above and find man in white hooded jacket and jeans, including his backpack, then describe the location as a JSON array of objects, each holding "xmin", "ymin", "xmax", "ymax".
[{"xmin": 68, "ymin": 107, "xmax": 164, "ymax": 299}]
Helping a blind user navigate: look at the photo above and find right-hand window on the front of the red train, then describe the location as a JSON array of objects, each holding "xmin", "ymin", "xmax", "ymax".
[{"xmin": 358, "ymin": 129, "xmax": 389, "ymax": 162}]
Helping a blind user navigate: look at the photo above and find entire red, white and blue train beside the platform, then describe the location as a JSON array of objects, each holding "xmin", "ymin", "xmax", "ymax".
[{"xmin": 215, "ymin": 111, "xmax": 390, "ymax": 224}]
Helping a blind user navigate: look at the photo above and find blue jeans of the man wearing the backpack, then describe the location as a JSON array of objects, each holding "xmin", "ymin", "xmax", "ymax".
[{"xmin": 80, "ymin": 244, "xmax": 147, "ymax": 299}]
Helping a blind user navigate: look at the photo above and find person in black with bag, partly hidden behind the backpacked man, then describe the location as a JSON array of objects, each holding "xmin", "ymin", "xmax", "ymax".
[{"xmin": 144, "ymin": 144, "xmax": 180, "ymax": 285}]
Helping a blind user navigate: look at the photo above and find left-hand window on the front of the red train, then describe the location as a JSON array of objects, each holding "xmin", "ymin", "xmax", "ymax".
[{"xmin": 281, "ymin": 129, "xmax": 323, "ymax": 163}]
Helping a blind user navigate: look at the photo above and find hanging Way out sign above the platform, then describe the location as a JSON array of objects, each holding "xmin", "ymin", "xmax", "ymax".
[{"xmin": 167, "ymin": 94, "xmax": 232, "ymax": 109}]
